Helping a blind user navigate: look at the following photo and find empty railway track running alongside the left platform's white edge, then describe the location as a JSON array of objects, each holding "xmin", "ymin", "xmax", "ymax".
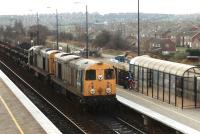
[{"xmin": 0, "ymin": 61, "xmax": 87, "ymax": 134}]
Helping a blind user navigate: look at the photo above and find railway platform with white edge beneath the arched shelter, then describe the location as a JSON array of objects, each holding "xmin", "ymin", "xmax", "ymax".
[{"xmin": 117, "ymin": 86, "xmax": 200, "ymax": 134}]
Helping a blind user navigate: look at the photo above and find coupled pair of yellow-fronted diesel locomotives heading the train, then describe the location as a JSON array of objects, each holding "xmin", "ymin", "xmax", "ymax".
[{"xmin": 28, "ymin": 46, "xmax": 116, "ymax": 104}]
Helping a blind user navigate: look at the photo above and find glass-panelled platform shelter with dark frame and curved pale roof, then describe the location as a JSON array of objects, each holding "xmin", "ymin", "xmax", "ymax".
[{"xmin": 129, "ymin": 55, "xmax": 200, "ymax": 108}]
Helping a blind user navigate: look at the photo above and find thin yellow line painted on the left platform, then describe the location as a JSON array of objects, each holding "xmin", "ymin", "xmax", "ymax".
[{"xmin": 0, "ymin": 96, "xmax": 24, "ymax": 134}]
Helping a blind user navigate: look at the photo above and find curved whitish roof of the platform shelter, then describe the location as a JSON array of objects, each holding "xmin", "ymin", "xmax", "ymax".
[{"xmin": 130, "ymin": 55, "xmax": 200, "ymax": 77}]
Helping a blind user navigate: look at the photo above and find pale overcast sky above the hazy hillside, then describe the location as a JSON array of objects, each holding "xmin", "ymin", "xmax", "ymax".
[{"xmin": 0, "ymin": 0, "xmax": 200, "ymax": 15}]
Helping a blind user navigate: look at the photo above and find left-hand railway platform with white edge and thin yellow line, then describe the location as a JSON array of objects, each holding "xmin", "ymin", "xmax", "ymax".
[{"xmin": 0, "ymin": 70, "xmax": 61, "ymax": 134}]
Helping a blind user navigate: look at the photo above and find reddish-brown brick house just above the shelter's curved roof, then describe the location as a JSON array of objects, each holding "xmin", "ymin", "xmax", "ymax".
[{"xmin": 147, "ymin": 38, "xmax": 176, "ymax": 55}]
